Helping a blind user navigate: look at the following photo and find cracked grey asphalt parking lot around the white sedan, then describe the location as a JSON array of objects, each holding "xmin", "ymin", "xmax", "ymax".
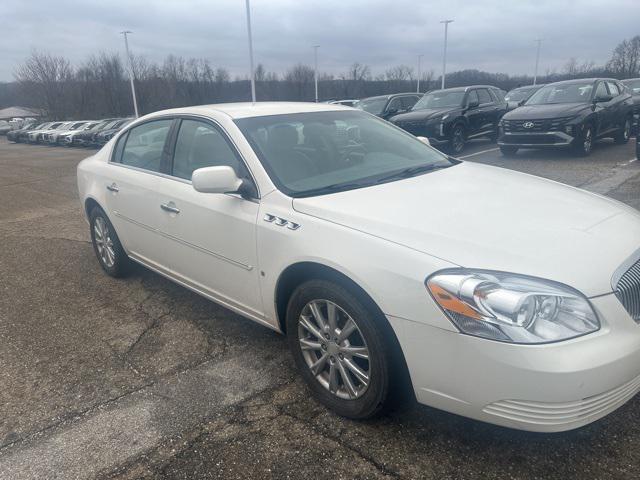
[{"xmin": 0, "ymin": 137, "xmax": 640, "ymax": 480}]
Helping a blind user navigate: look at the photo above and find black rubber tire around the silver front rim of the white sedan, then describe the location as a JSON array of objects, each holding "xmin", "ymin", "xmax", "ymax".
[{"xmin": 286, "ymin": 280, "xmax": 396, "ymax": 419}]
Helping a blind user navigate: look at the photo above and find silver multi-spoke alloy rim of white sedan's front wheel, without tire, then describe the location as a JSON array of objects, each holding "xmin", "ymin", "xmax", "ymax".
[{"xmin": 298, "ymin": 300, "xmax": 371, "ymax": 400}]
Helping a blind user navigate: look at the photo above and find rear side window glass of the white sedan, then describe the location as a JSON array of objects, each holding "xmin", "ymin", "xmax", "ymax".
[{"xmin": 120, "ymin": 120, "xmax": 173, "ymax": 172}]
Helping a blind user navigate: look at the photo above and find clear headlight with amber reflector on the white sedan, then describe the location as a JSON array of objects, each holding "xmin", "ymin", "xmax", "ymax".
[{"xmin": 426, "ymin": 269, "xmax": 600, "ymax": 344}]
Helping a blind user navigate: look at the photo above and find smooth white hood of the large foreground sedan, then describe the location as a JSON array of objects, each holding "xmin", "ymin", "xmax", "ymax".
[{"xmin": 293, "ymin": 162, "xmax": 640, "ymax": 296}]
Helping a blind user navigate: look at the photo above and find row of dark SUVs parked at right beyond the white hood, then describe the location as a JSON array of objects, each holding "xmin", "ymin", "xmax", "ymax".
[{"xmin": 354, "ymin": 78, "xmax": 640, "ymax": 155}]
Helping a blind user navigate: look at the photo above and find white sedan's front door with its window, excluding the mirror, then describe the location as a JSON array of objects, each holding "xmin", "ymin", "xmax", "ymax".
[{"xmin": 157, "ymin": 118, "xmax": 263, "ymax": 317}]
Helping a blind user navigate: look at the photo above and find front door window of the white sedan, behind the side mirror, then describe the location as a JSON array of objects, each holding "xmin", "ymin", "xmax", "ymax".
[{"xmin": 172, "ymin": 120, "xmax": 245, "ymax": 180}]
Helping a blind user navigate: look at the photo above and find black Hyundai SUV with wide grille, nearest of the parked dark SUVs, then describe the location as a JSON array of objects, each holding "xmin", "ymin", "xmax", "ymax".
[{"xmin": 498, "ymin": 78, "xmax": 633, "ymax": 155}]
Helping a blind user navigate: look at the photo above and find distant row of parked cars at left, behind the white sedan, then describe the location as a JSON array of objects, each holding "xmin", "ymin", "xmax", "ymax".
[{"xmin": 7, "ymin": 118, "xmax": 133, "ymax": 148}]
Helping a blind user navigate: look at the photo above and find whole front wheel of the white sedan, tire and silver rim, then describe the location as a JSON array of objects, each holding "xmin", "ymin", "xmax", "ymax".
[{"xmin": 287, "ymin": 280, "xmax": 392, "ymax": 419}]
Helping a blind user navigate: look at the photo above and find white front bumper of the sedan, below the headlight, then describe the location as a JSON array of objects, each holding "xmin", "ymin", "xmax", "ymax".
[{"xmin": 388, "ymin": 294, "xmax": 640, "ymax": 432}]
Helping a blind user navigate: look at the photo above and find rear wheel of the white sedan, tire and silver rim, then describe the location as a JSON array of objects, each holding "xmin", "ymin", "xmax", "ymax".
[{"xmin": 89, "ymin": 207, "xmax": 131, "ymax": 278}]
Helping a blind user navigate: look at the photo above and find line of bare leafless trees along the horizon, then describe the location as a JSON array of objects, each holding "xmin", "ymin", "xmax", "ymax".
[{"xmin": 0, "ymin": 36, "xmax": 640, "ymax": 120}]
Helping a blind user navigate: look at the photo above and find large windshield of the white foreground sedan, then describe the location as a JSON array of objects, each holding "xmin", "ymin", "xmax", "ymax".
[{"xmin": 235, "ymin": 111, "xmax": 453, "ymax": 197}]
